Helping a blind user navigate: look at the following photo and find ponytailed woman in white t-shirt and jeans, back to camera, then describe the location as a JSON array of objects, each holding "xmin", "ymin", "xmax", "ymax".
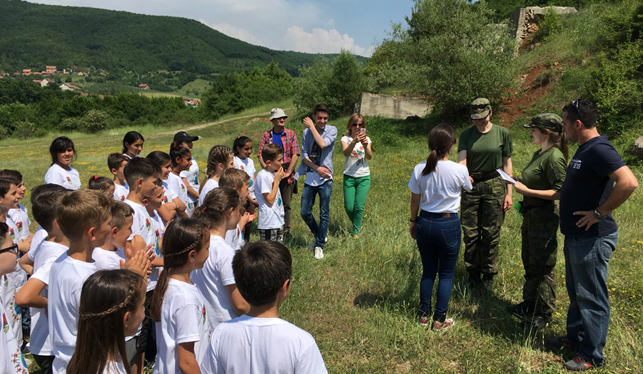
[{"xmin": 409, "ymin": 125, "xmax": 472, "ymax": 331}]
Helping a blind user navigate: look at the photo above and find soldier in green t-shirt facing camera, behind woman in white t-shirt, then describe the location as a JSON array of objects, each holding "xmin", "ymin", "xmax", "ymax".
[{"xmin": 458, "ymin": 98, "xmax": 513, "ymax": 291}]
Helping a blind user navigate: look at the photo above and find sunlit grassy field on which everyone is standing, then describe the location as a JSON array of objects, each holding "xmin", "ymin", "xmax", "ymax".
[{"xmin": 0, "ymin": 103, "xmax": 643, "ymax": 373}]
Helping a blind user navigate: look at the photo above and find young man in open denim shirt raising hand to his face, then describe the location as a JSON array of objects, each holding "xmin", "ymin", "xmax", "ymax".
[{"xmin": 297, "ymin": 104, "xmax": 337, "ymax": 260}]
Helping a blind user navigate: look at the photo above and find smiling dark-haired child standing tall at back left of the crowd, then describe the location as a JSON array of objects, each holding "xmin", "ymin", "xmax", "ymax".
[{"xmin": 45, "ymin": 136, "xmax": 81, "ymax": 190}]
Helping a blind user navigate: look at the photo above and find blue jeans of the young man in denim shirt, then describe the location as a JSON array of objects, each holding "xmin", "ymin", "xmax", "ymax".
[{"xmin": 301, "ymin": 179, "xmax": 333, "ymax": 248}]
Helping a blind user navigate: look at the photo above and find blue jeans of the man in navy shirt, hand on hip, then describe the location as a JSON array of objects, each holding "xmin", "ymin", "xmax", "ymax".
[{"xmin": 564, "ymin": 232, "xmax": 618, "ymax": 365}]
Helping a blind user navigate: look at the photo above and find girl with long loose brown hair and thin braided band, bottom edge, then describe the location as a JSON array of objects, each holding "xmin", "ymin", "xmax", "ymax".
[{"xmin": 67, "ymin": 269, "xmax": 147, "ymax": 374}]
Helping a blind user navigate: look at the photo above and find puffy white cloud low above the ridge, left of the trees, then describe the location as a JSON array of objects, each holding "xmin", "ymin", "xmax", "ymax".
[{"xmin": 284, "ymin": 26, "xmax": 373, "ymax": 55}]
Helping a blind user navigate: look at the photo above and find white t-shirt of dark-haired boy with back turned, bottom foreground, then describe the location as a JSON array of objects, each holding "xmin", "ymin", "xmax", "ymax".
[{"xmin": 201, "ymin": 315, "xmax": 328, "ymax": 374}]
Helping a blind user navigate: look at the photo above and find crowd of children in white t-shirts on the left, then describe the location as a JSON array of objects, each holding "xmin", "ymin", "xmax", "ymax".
[{"xmin": 0, "ymin": 126, "xmax": 326, "ymax": 373}]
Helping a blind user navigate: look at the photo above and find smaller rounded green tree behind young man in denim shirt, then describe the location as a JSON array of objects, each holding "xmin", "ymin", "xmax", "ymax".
[{"xmin": 293, "ymin": 51, "xmax": 367, "ymax": 115}]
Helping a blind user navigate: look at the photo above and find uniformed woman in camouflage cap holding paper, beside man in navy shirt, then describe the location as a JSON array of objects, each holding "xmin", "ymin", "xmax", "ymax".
[{"xmin": 507, "ymin": 113, "xmax": 568, "ymax": 328}]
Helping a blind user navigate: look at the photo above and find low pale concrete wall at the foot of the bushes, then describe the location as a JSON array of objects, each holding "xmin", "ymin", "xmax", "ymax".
[{"xmin": 356, "ymin": 92, "xmax": 431, "ymax": 119}]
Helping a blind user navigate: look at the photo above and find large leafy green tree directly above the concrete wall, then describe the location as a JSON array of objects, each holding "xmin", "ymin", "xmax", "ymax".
[{"xmin": 369, "ymin": 0, "xmax": 515, "ymax": 112}]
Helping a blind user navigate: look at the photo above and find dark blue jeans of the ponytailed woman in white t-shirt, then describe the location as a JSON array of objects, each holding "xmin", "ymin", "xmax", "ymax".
[{"xmin": 415, "ymin": 211, "xmax": 461, "ymax": 322}]
